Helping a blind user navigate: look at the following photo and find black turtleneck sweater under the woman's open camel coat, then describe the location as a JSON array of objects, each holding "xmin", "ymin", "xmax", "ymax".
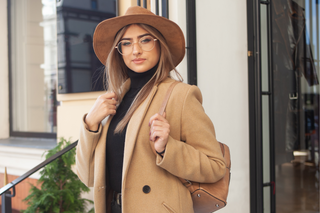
[{"xmin": 106, "ymin": 66, "xmax": 157, "ymax": 193}]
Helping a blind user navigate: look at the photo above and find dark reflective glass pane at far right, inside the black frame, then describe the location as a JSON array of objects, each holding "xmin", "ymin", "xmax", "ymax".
[{"xmin": 272, "ymin": 0, "xmax": 320, "ymax": 213}]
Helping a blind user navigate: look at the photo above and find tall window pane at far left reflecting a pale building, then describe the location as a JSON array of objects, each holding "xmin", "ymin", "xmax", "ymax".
[{"xmin": 9, "ymin": 0, "xmax": 58, "ymax": 133}]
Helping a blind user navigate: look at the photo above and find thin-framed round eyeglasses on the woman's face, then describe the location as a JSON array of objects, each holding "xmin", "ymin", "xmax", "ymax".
[{"xmin": 115, "ymin": 36, "xmax": 157, "ymax": 55}]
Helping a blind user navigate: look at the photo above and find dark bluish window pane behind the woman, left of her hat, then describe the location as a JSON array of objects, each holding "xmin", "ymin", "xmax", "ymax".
[{"xmin": 57, "ymin": 0, "xmax": 116, "ymax": 94}]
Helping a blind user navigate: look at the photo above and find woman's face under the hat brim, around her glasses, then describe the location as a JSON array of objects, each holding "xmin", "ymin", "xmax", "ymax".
[{"xmin": 121, "ymin": 24, "xmax": 160, "ymax": 73}]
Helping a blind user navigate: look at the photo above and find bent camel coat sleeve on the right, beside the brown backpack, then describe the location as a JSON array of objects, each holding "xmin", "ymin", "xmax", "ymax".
[{"xmin": 156, "ymin": 86, "xmax": 226, "ymax": 183}]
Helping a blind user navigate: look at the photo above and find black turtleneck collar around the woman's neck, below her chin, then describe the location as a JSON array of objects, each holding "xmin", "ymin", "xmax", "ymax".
[{"xmin": 127, "ymin": 64, "xmax": 158, "ymax": 89}]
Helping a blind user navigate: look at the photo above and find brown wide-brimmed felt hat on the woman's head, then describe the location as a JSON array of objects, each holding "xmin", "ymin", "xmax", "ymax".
[{"xmin": 93, "ymin": 6, "xmax": 185, "ymax": 66}]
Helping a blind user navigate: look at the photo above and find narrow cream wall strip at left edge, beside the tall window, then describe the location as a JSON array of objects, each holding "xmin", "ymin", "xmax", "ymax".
[{"xmin": 0, "ymin": 1, "xmax": 9, "ymax": 139}]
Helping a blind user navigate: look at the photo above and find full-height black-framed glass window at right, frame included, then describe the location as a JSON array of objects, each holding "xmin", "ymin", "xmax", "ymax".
[{"xmin": 248, "ymin": 0, "xmax": 320, "ymax": 213}]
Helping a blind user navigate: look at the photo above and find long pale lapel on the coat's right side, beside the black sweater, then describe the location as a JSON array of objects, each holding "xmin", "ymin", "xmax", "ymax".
[{"xmin": 122, "ymin": 86, "xmax": 158, "ymax": 186}]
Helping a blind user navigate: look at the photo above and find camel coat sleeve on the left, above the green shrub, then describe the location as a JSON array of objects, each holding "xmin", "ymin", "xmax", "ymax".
[{"xmin": 76, "ymin": 115, "xmax": 102, "ymax": 187}]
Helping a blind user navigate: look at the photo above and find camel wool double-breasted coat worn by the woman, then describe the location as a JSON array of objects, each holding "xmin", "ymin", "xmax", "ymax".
[{"xmin": 76, "ymin": 78, "xmax": 225, "ymax": 213}]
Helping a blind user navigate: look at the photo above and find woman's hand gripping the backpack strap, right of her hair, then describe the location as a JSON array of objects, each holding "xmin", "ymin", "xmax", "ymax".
[{"xmin": 149, "ymin": 113, "xmax": 170, "ymax": 153}]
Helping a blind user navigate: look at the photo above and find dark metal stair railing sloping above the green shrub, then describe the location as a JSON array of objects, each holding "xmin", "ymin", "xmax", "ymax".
[{"xmin": 0, "ymin": 141, "xmax": 78, "ymax": 213}]
